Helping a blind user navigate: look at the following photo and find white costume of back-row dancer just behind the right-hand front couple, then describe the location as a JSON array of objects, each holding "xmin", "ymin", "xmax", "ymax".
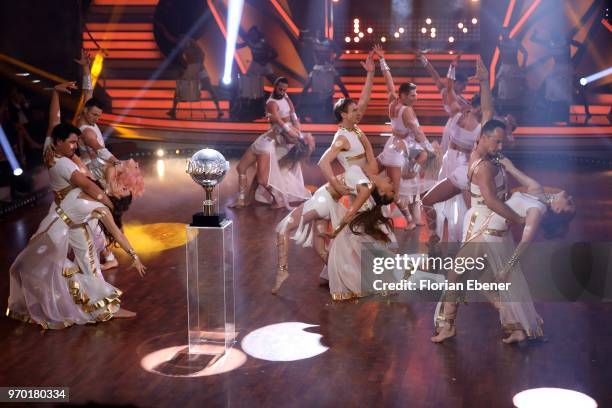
[{"xmin": 434, "ymin": 113, "xmax": 481, "ymax": 242}]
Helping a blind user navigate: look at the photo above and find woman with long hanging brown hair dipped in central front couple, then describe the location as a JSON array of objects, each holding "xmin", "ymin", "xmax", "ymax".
[{"xmin": 323, "ymin": 166, "xmax": 396, "ymax": 300}]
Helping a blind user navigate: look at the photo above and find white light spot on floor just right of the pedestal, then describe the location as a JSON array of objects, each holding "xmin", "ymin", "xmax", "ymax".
[{"xmin": 240, "ymin": 322, "xmax": 329, "ymax": 361}]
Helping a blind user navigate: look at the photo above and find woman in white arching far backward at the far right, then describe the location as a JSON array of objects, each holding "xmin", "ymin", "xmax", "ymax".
[{"xmin": 432, "ymin": 151, "xmax": 576, "ymax": 344}]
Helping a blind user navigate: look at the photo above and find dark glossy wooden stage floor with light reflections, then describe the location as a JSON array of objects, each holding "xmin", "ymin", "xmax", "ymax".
[{"xmin": 0, "ymin": 151, "xmax": 612, "ymax": 407}]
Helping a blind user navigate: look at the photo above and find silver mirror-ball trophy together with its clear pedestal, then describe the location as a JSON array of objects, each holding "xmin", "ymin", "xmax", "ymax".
[{"xmin": 186, "ymin": 149, "xmax": 235, "ymax": 361}]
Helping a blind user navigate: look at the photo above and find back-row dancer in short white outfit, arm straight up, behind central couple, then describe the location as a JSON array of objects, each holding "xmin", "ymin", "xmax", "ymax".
[{"xmin": 374, "ymin": 45, "xmax": 440, "ymax": 230}]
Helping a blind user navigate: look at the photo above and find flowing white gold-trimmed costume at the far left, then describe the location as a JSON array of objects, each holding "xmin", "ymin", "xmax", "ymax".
[{"xmin": 7, "ymin": 158, "xmax": 121, "ymax": 329}]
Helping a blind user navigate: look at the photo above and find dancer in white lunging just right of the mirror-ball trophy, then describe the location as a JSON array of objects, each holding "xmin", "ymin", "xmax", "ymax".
[{"xmin": 230, "ymin": 77, "xmax": 315, "ymax": 209}]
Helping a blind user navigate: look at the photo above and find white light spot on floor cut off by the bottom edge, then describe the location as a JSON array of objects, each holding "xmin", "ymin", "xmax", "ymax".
[{"xmin": 512, "ymin": 388, "xmax": 597, "ymax": 408}]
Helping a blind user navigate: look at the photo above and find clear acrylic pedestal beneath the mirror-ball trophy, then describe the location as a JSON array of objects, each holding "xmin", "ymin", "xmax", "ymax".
[{"xmin": 186, "ymin": 219, "xmax": 236, "ymax": 355}]
